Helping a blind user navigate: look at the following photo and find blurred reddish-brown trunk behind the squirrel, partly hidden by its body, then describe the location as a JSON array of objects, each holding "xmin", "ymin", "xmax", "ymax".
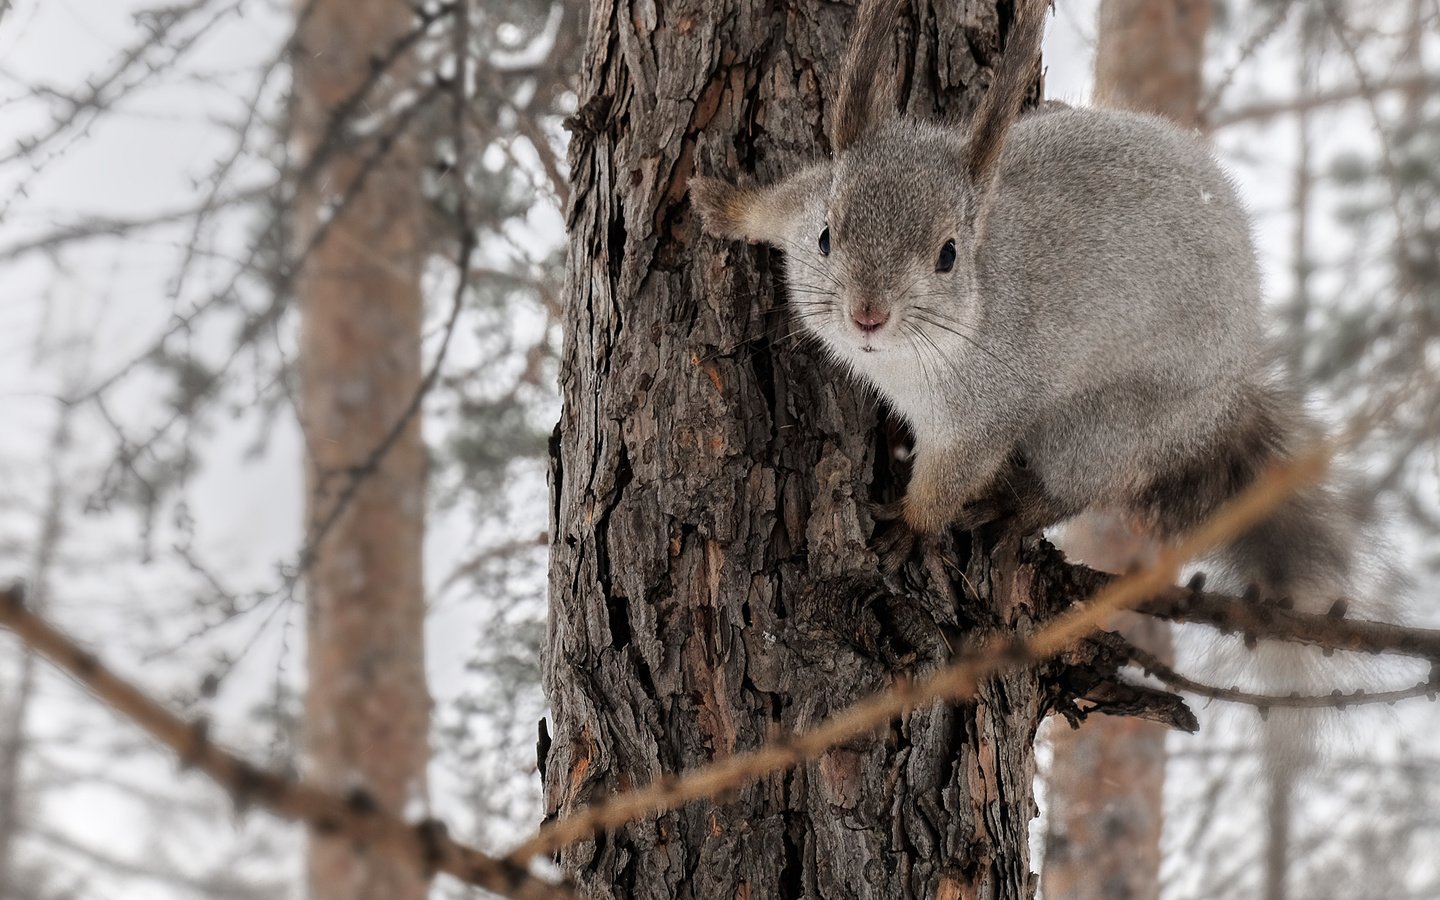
[{"xmin": 1044, "ymin": 0, "xmax": 1211, "ymax": 900}]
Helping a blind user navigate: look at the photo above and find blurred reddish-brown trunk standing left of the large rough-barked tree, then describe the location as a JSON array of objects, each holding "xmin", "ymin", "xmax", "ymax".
[{"xmin": 294, "ymin": 0, "xmax": 429, "ymax": 900}]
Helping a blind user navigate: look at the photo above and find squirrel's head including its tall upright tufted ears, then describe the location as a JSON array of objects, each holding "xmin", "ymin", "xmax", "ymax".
[{"xmin": 690, "ymin": 0, "xmax": 1048, "ymax": 356}]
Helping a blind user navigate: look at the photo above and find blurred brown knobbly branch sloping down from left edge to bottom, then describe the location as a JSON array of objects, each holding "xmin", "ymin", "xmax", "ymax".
[{"xmin": 0, "ymin": 588, "xmax": 575, "ymax": 900}]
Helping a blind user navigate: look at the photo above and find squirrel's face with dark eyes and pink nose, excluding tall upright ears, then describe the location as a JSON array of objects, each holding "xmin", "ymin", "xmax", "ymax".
[{"xmin": 690, "ymin": 117, "xmax": 984, "ymax": 354}]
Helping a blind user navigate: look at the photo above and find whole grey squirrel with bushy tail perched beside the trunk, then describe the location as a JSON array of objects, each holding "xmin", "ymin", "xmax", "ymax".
[{"xmin": 690, "ymin": 0, "xmax": 1356, "ymax": 630}]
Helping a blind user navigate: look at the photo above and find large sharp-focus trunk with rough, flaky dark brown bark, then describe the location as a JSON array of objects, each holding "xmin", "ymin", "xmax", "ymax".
[{"xmin": 540, "ymin": 0, "xmax": 1064, "ymax": 899}]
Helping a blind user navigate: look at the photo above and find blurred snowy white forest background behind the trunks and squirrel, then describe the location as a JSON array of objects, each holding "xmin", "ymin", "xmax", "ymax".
[{"xmin": 0, "ymin": 0, "xmax": 1440, "ymax": 900}]
